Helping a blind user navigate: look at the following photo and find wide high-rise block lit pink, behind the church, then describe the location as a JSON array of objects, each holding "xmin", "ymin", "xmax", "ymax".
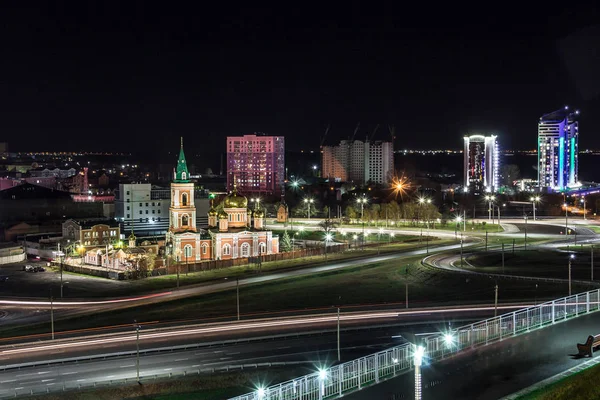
[{"xmin": 227, "ymin": 135, "xmax": 285, "ymax": 193}]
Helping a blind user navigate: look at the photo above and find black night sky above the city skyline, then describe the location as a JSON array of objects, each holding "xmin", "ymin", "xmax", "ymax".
[{"xmin": 0, "ymin": 1, "xmax": 600, "ymax": 164}]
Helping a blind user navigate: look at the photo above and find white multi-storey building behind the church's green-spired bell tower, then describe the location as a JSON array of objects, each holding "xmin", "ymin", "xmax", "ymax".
[{"xmin": 115, "ymin": 183, "xmax": 210, "ymax": 235}]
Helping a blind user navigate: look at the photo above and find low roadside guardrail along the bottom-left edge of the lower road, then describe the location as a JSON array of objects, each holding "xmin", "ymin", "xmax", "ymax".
[{"xmin": 0, "ymin": 361, "xmax": 313, "ymax": 399}]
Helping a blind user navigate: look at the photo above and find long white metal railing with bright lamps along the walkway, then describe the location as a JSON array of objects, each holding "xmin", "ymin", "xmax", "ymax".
[{"xmin": 230, "ymin": 289, "xmax": 600, "ymax": 400}]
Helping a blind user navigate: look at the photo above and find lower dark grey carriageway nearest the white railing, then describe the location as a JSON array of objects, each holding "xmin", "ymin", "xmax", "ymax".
[{"xmin": 0, "ymin": 319, "xmax": 500, "ymax": 398}]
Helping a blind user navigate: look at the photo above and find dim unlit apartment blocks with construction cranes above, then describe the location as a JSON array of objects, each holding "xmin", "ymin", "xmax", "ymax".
[{"xmin": 321, "ymin": 140, "xmax": 394, "ymax": 184}]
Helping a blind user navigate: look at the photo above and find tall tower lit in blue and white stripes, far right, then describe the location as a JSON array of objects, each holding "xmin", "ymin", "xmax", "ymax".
[{"xmin": 538, "ymin": 107, "xmax": 579, "ymax": 190}]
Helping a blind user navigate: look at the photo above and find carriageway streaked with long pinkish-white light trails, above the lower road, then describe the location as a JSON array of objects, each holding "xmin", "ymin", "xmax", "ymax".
[{"xmin": 0, "ymin": 304, "xmax": 530, "ymax": 368}]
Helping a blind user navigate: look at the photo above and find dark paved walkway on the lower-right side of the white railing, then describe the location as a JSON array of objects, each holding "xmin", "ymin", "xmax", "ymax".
[{"xmin": 345, "ymin": 300, "xmax": 600, "ymax": 400}]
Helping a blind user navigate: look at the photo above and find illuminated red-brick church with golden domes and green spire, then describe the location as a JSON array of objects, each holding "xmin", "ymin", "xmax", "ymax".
[{"xmin": 166, "ymin": 139, "xmax": 279, "ymax": 262}]
